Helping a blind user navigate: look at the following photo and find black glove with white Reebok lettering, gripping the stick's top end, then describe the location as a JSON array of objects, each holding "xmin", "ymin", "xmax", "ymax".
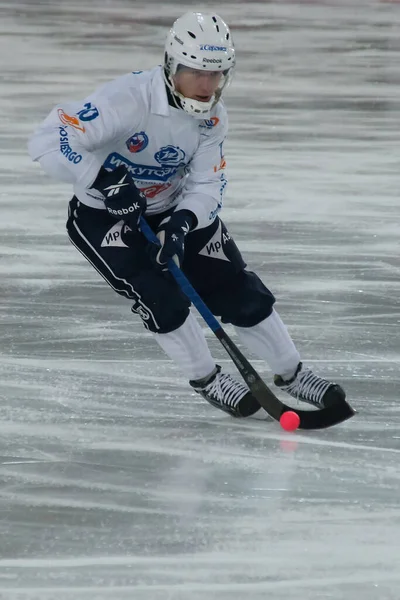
[{"xmin": 92, "ymin": 165, "xmax": 146, "ymax": 229}]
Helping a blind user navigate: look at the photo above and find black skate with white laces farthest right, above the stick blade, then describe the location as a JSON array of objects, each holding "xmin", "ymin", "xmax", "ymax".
[{"xmin": 274, "ymin": 363, "xmax": 346, "ymax": 408}]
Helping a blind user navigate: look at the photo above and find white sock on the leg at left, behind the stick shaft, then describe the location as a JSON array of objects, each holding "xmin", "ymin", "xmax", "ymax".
[{"xmin": 153, "ymin": 313, "xmax": 215, "ymax": 379}]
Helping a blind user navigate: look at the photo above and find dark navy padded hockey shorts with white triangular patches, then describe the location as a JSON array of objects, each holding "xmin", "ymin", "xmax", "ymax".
[{"xmin": 67, "ymin": 197, "xmax": 275, "ymax": 333}]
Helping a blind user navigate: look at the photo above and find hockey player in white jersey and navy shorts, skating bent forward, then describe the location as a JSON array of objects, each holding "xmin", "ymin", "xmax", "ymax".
[{"xmin": 29, "ymin": 13, "xmax": 345, "ymax": 417}]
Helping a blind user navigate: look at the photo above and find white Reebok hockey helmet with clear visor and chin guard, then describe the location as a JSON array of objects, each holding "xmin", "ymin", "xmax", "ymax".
[{"xmin": 164, "ymin": 12, "xmax": 235, "ymax": 119}]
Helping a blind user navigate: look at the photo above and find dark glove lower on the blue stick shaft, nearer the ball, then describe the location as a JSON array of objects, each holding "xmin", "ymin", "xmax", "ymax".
[{"xmin": 155, "ymin": 210, "xmax": 197, "ymax": 270}]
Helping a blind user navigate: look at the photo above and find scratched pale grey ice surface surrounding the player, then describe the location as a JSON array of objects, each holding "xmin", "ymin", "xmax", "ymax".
[{"xmin": 0, "ymin": 0, "xmax": 400, "ymax": 600}]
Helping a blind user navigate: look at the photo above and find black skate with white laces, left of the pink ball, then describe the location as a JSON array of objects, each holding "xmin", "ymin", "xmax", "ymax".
[{"xmin": 189, "ymin": 365, "xmax": 260, "ymax": 417}]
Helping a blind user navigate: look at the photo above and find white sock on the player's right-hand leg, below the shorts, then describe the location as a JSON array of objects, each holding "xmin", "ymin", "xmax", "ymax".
[{"xmin": 235, "ymin": 309, "xmax": 300, "ymax": 379}]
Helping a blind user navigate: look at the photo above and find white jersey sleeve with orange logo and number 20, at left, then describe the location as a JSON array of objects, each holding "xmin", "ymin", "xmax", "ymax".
[{"xmin": 28, "ymin": 90, "xmax": 140, "ymax": 188}]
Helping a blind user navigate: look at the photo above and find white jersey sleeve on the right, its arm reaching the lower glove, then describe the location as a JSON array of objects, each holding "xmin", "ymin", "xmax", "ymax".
[{"xmin": 176, "ymin": 107, "xmax": 228, "ymax": 229}]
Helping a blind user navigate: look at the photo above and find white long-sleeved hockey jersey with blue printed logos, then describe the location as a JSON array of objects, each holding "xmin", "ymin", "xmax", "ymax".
[{"xmin": 29, "ymin": 67, "xmax": 228, "ymax": 228}]
